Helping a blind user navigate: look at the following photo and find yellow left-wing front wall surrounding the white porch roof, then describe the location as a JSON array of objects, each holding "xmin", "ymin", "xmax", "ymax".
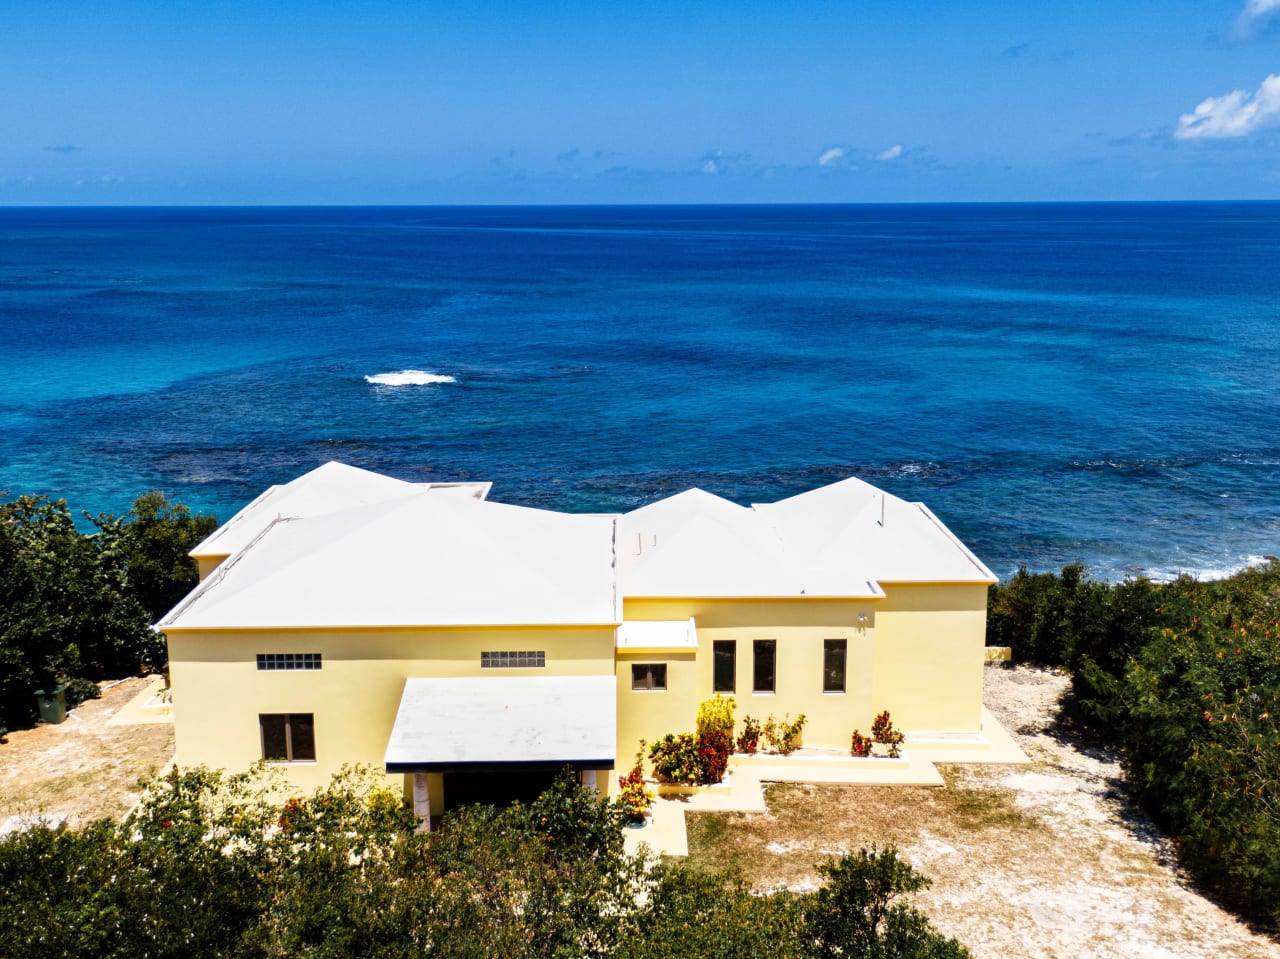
[{"xmin": 169, "ymin": 627, "xmax": 616, "ymax": 793}]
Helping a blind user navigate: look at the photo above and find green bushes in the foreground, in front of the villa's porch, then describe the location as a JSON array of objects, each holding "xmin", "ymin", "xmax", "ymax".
[{"xmin": 0, "ymin": 766, "xmax": 969, "ymax": 959}]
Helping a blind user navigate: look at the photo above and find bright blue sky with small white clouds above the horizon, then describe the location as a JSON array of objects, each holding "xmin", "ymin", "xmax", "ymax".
[{"xmin": 0, "ymin": 0, "xmax": 1280, "ymax": 205}]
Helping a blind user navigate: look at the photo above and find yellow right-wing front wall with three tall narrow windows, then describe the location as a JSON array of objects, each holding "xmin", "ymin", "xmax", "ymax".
[{"xmin": 617, "ymin": 584, "xmax": 987, "ymax": 767}]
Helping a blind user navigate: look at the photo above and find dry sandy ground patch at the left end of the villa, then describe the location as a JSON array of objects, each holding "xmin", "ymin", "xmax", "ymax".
[{"xmin": 0, "ymin": 679, "xmax": 173, "ymax": 826}]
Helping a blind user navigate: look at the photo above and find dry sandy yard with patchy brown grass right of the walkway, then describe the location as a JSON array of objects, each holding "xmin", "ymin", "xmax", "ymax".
[{"xmin": 689, "ymin": 667, "xmax": 1280, "ymax": 959}]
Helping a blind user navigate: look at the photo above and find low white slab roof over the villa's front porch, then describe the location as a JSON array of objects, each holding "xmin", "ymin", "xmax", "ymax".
[{"xmin": 384, "ymin": 673, "xmax": 617, "ymax": 772}]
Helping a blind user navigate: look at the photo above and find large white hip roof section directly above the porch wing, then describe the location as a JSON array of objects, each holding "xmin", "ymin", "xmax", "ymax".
[{"xmin": 160, "ymin": 488, "xmax": 622, "ymax": 629}]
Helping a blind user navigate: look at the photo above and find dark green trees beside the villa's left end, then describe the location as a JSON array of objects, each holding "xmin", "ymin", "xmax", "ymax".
[{"xmin": 0, "ymin": 492, "xmax": 218, "ymax": 737}]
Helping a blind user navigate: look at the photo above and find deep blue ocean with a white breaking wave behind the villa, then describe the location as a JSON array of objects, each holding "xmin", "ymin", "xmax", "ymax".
[{"xmin": 0, "ymin": 204, "xmax": 1280, "ymax": 579}]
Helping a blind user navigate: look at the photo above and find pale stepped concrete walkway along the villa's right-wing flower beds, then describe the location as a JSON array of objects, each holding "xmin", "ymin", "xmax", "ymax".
[{"xmin": 623, "ymin": 707, "xmax": 1029, "ymax": 855}]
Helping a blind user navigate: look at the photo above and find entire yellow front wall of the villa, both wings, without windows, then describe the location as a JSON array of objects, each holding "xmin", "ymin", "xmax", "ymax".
[{"xmin": 169, "ymin": 584, "xmax": 987, "ymax": 798}]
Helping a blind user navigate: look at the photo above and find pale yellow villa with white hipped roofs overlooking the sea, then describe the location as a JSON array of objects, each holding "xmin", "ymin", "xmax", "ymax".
[{"xmin": 159, "ymin": 462, "xmax": 996, "ymax": 814}]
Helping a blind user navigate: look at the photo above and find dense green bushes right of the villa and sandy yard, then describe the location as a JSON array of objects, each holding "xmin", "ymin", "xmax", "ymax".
[{"xmin": 987, "ymin": 560, "xmax": 1280, "ymax": 928}]
